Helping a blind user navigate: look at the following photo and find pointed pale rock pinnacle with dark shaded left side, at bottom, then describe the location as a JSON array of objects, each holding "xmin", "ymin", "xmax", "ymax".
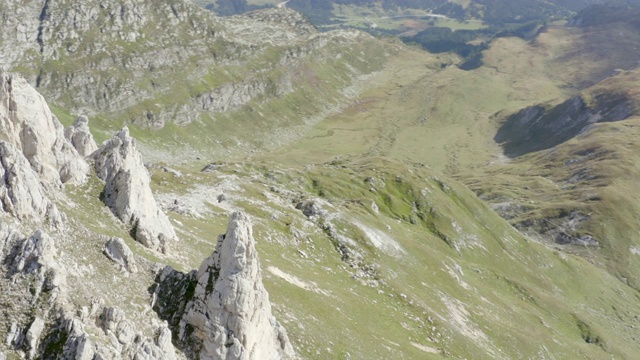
[{"xmin": 180, "ymin": 212, "xmax": 293, "ymax": 359}]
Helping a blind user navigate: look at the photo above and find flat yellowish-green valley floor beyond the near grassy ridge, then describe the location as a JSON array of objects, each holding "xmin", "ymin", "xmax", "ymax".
[{"xmin": 268, "ymin": 33, "xmax": 567, "ymax": 173}]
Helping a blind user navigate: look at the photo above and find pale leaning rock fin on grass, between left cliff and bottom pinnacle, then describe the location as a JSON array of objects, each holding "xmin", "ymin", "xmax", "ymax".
[{"xmin": 93, "ymin": 127, "xmax": 176, "ymax": 251}]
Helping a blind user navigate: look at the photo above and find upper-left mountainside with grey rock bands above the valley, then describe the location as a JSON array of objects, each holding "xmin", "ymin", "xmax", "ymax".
[{"xmin": 0, "ymin": 0, "xmax": 393, "ymax": 159}]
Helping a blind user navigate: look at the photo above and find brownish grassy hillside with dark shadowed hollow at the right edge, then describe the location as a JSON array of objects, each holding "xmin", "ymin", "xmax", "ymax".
[{"xmin": 461, "ymin": 70, "xmax": 639, "ymax": 287}]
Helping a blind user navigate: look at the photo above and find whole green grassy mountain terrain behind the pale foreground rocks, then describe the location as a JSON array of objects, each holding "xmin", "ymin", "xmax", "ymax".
[{"xmin": 0, "ymin": 0, "xmax": 640, "ymax": 359}]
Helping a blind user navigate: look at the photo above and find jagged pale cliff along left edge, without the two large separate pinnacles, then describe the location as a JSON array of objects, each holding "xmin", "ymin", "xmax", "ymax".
[{"xmin": 0, "ymin": 73, "xmax": 180, "ymax": 360}]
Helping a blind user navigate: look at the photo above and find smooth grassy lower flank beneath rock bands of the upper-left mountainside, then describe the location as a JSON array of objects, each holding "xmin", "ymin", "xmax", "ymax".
[{"xmin": 53, "ymin": 35, "xmax": 398, "ymax": 165}]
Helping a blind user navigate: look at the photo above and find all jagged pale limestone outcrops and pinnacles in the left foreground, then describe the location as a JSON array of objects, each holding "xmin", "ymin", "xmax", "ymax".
[{"xmin": 0, "ymin": 74, "xmax": 292, "ymax": 360}]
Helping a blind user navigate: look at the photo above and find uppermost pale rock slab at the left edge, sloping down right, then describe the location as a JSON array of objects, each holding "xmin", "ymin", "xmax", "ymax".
[{"xmin": 0, "ymin": 73, "xmax": 88, "ymax": 188}]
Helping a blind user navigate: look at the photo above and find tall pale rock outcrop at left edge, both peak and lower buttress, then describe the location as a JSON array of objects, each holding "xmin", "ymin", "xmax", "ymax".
[{"xmin": 0, "ymin": 72, "xmax": 88, "ymax": 229}]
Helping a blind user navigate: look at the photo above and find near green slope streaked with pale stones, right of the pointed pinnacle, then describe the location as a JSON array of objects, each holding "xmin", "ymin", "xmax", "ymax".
[{"xmin": 121, "ymin": 158, "xmax": 640, "ymax": 359}]
